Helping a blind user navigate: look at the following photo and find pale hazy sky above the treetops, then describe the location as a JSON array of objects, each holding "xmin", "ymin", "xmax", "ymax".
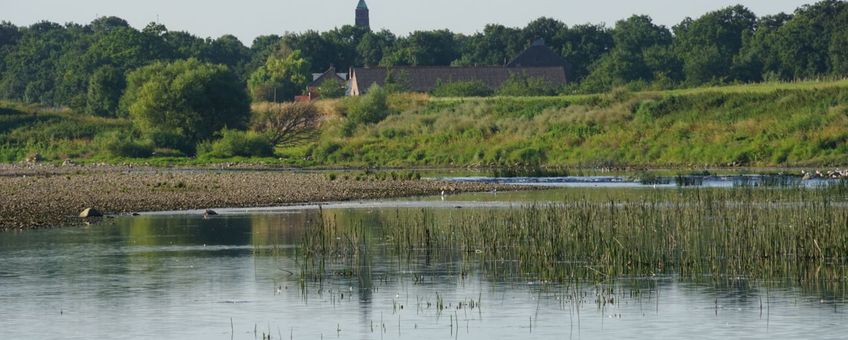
[{"xmin": 0, "ymin": 0, "xmax": 817, "ymax": 46}]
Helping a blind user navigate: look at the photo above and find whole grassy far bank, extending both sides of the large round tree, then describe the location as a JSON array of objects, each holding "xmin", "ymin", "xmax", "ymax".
[{"xmin": 0, "ymin": 80, "xmax": 848, "ymax": 168}]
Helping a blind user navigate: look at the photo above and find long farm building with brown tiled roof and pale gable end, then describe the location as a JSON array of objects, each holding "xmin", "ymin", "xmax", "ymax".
[{"xmin": 349, "ymin": 40, "xmax": 568, "ymax": 96}]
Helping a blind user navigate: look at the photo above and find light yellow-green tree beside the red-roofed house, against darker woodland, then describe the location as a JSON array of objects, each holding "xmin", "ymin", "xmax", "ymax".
[{"xmin": 248, "ymin": 51, "xmax": 311, "ymax": 102}]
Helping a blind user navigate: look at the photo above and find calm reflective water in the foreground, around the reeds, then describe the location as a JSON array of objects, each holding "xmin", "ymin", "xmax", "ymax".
[{"xmin": 0, "ymin": 187, "xmax": 848, "ymax": 339}]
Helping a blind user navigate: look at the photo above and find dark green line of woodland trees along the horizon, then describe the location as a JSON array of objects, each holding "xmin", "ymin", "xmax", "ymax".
[{"xmin": 0, "ymin": 0, "xmax": 848, "ymax": 116}]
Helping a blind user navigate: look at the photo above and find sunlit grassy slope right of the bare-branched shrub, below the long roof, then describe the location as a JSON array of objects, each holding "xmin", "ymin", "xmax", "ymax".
[{"xmin": 305, "ymin": 81, "xmax": 848, "ymax": 167}]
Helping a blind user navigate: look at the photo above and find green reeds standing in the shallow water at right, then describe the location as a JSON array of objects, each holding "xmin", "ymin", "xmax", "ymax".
[{"xmin": 301, "ymin": 183, "xmax": 848, "ymax": 291}]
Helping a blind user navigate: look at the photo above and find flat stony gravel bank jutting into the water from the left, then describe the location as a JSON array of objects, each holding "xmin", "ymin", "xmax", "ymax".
[{"xmin": 0, "ymin": 166, "xmax": 514, "ymax": 230}]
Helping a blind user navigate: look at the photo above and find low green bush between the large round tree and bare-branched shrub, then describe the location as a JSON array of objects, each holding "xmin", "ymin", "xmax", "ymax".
[{"xmin": 197, "ymin": 129, "xmax": 274, "ymax": 158}]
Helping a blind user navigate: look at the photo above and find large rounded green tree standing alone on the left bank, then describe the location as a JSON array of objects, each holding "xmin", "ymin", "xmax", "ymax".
[{"xmin": 121, "ymin": 59, "xmax": 250, "ymax": 147}]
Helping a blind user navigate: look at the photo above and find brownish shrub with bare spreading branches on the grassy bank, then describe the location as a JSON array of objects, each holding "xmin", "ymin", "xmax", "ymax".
[{"xmin": 252, "ymin": 103, "xmax": 321, "ymax": 147}]
